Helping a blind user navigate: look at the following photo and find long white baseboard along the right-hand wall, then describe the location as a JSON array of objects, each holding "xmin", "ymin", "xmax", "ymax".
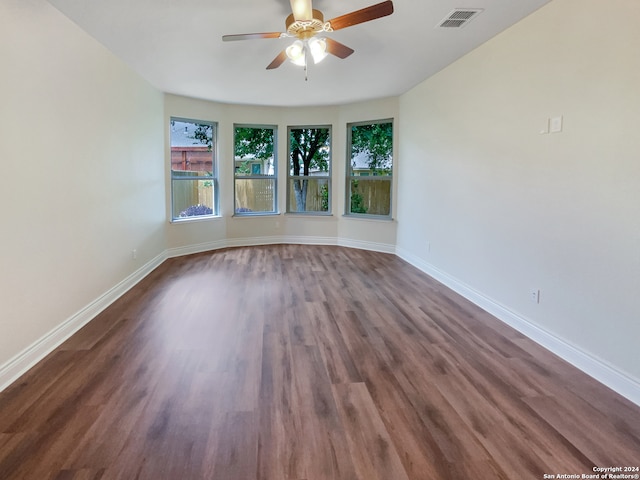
[{"xmin": 396, "ymin": 249, "xmax": 640, "ymax": 406}]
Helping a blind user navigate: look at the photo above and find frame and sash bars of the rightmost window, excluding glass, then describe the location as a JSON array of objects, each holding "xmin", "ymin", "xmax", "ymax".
[{"xmin": 344, "ymin": 118, "xmax": 395, "ymax": 220}]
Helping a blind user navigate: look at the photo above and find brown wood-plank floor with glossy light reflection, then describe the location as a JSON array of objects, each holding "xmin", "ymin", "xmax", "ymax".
[{"xmin": 0, "ymin": 245, "xmax": 640, "ymax": 480}]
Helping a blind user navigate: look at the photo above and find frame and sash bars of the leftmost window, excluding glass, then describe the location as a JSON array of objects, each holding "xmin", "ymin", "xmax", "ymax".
[{"xmin": 169, "ymin": 116, "xmax": 220, "ymax": 223}]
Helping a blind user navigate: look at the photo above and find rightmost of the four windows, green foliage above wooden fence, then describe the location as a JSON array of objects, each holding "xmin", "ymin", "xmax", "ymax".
[{"xmin": 346, "ymin": 120, "xmax": 393, "ymax": 218}]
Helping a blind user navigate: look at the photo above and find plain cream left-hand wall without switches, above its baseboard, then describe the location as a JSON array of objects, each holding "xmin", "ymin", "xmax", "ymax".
[{"xmin": 0, "ymin": 0, "xmax": 166, "ymax": 382}]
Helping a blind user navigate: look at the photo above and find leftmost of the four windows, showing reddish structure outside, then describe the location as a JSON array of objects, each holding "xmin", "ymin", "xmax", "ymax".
[{"xmin": 171, "ymin": 118, "xmax": 218, "ymax": 220}]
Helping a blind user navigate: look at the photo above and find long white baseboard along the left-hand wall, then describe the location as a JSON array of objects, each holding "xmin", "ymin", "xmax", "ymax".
[{"xmin": 0, "ymin": 252, "xmax": 166, "ymax": 392}]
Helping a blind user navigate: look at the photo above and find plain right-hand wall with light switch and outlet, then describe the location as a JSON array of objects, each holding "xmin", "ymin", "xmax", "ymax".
[{"xmin": 397, "ymin": 0, "xmax": 640, "ymax": 402}]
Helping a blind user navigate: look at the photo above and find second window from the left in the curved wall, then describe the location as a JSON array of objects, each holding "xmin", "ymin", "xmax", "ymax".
[{"xmin": 233, "ymin": 125, "xmax": 278, "ymax": 215}]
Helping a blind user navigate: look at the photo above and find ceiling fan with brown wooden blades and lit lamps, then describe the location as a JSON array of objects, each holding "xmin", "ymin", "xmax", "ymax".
[{"xmin": 222, "ymin": 0, "xmax": 393, "ymax": 70}]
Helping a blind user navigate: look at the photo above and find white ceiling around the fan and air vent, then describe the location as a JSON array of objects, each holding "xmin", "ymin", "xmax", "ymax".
[{"xmin": 49, "ymin": 0, "xmax": 550, "ymax": 106}]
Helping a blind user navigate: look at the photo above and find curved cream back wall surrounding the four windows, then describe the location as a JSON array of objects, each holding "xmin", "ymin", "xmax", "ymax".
[{"xmin": 165, "ymin": 95, "xmax": 398, "ymax": 255}]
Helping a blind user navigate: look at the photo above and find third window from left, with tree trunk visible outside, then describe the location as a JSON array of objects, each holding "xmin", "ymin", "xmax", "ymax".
[{"xmin": 287, "ymin": 127, "xmax": 331, "ymax": 214}]
